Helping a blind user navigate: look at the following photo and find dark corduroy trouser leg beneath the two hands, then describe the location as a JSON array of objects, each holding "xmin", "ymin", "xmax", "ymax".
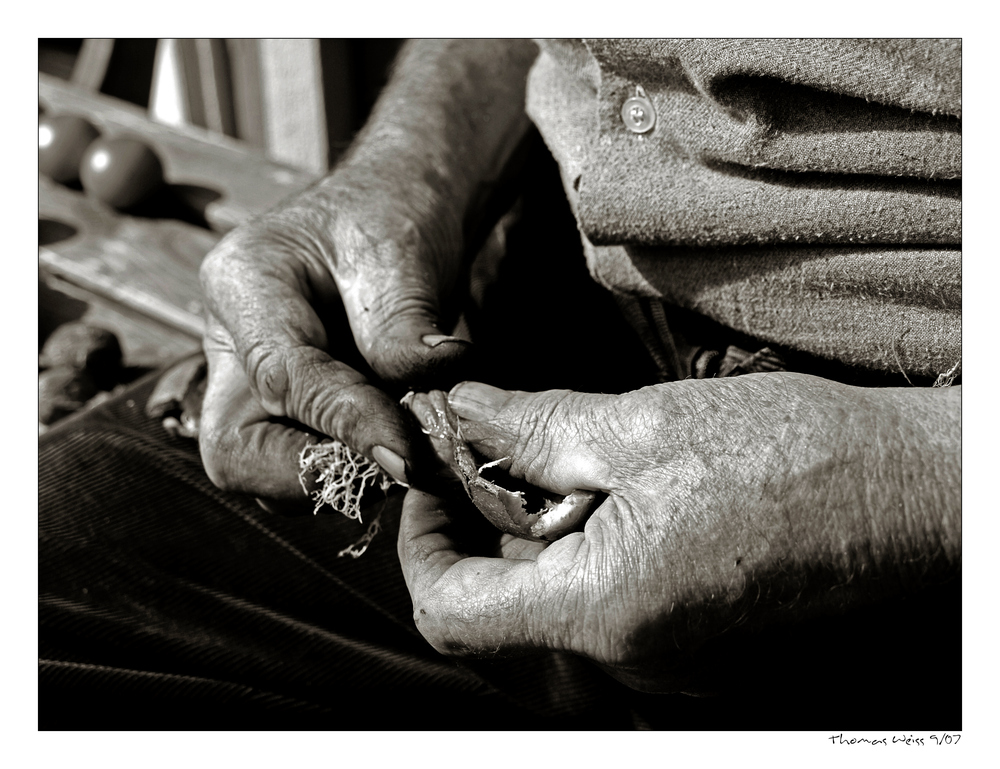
[{"xmin": 39, "ymin": 382, "xmax": 631, "ymax": 729}]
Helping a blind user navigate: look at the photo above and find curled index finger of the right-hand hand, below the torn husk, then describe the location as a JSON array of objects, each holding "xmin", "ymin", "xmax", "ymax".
[{"xmin": 398, "ymin": 489, "xmax": 561, "ymax": 655}]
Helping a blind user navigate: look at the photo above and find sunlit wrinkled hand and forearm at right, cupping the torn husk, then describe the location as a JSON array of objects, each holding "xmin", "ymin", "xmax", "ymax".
[{"xmin": 399, "ymin": 373, "xmax": 961, "ymax": 691}]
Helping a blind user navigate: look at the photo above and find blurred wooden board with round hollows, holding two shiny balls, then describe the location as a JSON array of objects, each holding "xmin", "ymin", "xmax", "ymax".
[{"xmin": 38, "ymin": 75, "xmax": 314, "ymax": 366}]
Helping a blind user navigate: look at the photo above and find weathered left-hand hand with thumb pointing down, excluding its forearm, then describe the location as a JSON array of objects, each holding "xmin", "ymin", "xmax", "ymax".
[{"xmin": 201, "ymin": 164, "xmax": 467, "ymax": 499}]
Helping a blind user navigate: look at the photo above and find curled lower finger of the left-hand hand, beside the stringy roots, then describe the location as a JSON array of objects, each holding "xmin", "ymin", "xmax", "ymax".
[{"xmin": 199, "ymin": 328, "xmax": 326, "ymax": 501}]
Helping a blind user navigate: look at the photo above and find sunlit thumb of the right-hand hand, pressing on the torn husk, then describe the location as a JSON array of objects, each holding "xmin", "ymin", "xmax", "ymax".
[{"xmin": 448, "ymin": 382, "xmax": 614, "ymax": 494}]
